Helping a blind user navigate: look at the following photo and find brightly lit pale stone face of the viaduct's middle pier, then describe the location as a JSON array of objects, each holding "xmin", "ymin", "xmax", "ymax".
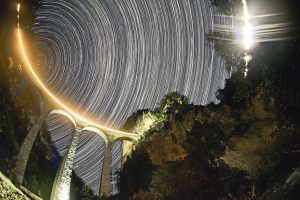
[{"xmin": 54, "ymin": 127, "xmax": 81, "ymax": 200}]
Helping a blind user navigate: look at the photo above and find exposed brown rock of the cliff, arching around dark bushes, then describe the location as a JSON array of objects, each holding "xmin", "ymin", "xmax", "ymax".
[{"xmin": 133, "ymin": 92, "xmax": 277, "ymax": 171}]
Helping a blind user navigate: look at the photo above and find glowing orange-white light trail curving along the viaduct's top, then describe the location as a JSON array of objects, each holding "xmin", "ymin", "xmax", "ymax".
[{"xmin": 17, "ymin": 4, "xmax": 138, "ymax": 136}]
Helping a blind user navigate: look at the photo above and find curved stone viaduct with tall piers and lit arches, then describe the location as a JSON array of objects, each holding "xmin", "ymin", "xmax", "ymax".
[{"xmin": 10, "ymin": 80, "xmax": 138, "ymax": 199}]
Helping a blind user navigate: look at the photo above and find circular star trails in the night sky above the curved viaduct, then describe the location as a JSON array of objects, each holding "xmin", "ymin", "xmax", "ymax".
[{"xmin": 32, "ymin": 0, "xmax": 230, "ymax": 128}]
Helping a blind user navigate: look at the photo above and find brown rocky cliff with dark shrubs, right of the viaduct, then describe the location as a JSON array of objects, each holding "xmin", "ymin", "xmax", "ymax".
[{"xmin": 121, "ymin": 90, "xmax": 292, "ymax": 199}]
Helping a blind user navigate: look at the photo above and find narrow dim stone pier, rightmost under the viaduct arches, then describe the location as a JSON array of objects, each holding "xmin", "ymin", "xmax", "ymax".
[{"xmin": 100, "ymin": 140, "xmax": 112, "ymax": 196}]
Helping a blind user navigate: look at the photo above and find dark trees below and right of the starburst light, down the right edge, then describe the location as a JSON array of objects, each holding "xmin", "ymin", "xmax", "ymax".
[{"xmin": 207, "ymin": 0, "xmax": 300, "ymax": 198}]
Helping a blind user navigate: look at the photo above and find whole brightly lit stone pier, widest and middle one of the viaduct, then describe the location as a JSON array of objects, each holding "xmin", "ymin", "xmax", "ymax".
[{"xmin": 50, "ymin": 127, "xmax": 82, "ymax": 200}]
